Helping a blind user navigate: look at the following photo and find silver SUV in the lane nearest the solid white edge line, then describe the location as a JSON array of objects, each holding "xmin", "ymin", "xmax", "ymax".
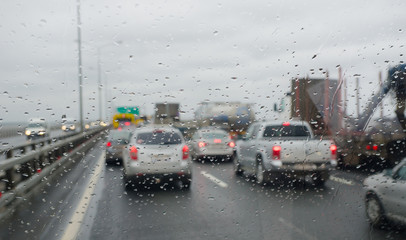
[{"xmin": 122, "ymin": 126, "xmax": 192, "ymax": 188}]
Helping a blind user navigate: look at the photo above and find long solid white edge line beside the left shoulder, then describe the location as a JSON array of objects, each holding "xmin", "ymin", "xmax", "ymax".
[{"xmin": 61, "ymin": 153, "xmax": 105, "ymax": 240}]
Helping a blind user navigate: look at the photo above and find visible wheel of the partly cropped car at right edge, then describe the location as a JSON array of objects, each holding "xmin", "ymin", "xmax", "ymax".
[{"xmin": 365, "ymin": 194, "xmax": 385, "ymax": 228}]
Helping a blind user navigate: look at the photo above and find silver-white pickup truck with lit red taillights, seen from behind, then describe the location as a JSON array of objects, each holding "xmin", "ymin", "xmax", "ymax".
[{"xmin": 233, "ymin": 121, "xmax": 337, "ymax": 186}]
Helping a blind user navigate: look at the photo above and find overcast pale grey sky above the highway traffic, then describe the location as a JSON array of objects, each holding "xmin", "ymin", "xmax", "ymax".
[{"xmin": 0, "ymin": 0, "xmax": 406, "ymax": 122}]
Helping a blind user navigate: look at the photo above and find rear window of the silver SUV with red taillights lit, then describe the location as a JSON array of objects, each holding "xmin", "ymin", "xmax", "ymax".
[{"xmin": 136, "ymin": 132, "xmax": 182, "ymax": 145}]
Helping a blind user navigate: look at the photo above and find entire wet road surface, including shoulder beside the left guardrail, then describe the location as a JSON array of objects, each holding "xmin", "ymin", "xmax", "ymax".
[{"xmin": 0, "ymin": 141, "xmax": 405, "ymax": 239}]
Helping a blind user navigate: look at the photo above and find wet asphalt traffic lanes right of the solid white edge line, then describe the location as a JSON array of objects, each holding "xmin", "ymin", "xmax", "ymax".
[{"xmin": 89, "ymin": 160, "xmax": 404, "ymax": 239}]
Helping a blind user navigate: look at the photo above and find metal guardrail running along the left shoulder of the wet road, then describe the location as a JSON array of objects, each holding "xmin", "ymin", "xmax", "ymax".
[{"xmin": 0, "ymin": 127, "xmax": 108, "ymax": 218}]
